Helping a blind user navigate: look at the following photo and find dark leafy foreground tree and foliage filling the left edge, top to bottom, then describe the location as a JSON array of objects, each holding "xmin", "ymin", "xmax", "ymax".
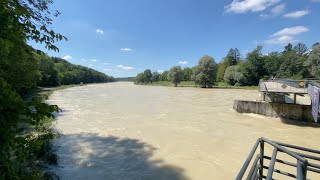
[{"xmin": 0, "ymin": 0, "xmax": 66, "ymax": 179}]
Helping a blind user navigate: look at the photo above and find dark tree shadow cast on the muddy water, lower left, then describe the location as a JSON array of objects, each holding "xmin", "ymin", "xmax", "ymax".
[{"xmin": 56, "ymin": 134, "xmax": 188, "ymax": 180}]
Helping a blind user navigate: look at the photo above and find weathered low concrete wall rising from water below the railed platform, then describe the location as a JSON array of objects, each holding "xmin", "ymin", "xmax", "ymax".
[{"xmin": 233, "ymin": 100, "xmax": 314, "ymax": 122}]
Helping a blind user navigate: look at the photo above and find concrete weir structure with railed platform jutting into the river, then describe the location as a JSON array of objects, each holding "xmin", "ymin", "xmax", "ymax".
[{"xmin": 233, "ymin": 79, "xmax": 320, "ymax": 123}]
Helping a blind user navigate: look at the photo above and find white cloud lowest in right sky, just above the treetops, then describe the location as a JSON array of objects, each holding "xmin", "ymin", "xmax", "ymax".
[{"xmin": 265, "ymin": 26, "xmax": 309, "ymax": 44}]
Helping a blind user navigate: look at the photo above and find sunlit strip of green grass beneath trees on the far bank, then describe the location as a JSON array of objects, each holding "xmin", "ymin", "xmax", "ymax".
[{"xmin": 138, "ymin": 81, "xmax": 258, "ymax": 90}]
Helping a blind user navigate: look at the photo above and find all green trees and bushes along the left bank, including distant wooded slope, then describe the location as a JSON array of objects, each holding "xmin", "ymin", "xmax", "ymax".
[{"xmin": 0, "ymin": 0, "xmax": 114, "ymax": 179}]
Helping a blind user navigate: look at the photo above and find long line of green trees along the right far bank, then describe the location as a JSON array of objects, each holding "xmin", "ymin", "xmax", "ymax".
[{"xmin": 135, "ymin": 43, "xmax": 320, "ymax": 87}]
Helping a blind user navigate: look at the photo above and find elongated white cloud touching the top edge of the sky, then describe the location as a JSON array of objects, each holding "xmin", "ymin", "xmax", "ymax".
[{"xmin": 224, "ymin": 0, "xmax": 281, "ymax": 13}]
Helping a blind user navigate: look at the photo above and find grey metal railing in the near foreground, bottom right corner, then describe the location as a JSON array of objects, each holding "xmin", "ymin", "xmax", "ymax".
[{"xmin": 236, "ymin": 137, "xmax": 320, "ymax": 180}]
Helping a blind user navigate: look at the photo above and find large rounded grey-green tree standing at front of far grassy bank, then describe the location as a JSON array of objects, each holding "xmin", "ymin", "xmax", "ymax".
[{"xmin": 193, "ymin": 55, "xmax": 218, "ymax": 88}]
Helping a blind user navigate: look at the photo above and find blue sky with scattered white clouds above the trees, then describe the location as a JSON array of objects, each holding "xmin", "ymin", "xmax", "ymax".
[{"xmin": 30, "ymin": 0, "xmax": 320, "ymax": 77}]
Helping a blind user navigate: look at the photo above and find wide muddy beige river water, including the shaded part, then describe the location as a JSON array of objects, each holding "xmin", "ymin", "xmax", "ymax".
[{"xmin": 49, "ymin": 82, "xmax": 320, "ymax": 180}]
